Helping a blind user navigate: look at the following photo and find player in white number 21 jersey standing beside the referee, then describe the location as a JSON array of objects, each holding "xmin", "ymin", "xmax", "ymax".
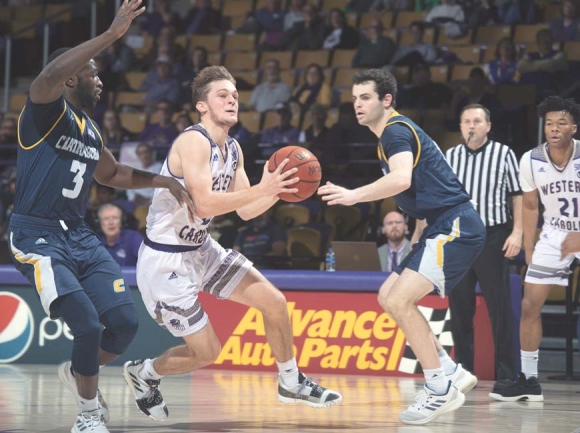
[{"xmin": 490, "ymin": 96, "xmax": 580, "ymax": 401}]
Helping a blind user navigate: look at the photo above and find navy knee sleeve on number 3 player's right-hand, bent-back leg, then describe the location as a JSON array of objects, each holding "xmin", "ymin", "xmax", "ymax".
[{"xmin": 101, "ymin": 304, "xmax": 139, "ymax": 355}]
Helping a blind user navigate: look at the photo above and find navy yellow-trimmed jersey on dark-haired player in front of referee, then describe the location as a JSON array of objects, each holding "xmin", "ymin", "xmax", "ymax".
[{"xmin": 378, "ymin": 111, "xmax": 470, "ymax": 221}]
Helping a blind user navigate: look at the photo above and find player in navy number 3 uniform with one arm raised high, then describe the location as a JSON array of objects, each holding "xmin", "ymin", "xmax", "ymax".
[{"xmin": 9, "ymin": 0, "xmax": 192, "ymax": 433}]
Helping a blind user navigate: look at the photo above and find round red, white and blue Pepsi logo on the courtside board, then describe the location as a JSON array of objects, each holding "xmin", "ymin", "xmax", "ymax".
[{"xmin": 0, "ymin": 292, "xmax": 34, "ymax": 364}]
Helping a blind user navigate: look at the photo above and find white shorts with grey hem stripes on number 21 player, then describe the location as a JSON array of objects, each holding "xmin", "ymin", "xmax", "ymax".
[{"xmin": 524, "ymin": 224, "xmax": 580, "ymax": 286}]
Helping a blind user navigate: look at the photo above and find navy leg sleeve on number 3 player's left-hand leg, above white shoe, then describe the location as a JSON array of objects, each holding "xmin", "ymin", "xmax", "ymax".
[{"xmin": 56, "ymin": 290, "xmax": 102, "ymax": 376}]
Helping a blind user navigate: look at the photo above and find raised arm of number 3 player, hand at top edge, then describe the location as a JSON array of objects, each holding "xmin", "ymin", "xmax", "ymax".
[{"xmin": 30, "ymin": 0, "xmax": 145, "ymax": 104}]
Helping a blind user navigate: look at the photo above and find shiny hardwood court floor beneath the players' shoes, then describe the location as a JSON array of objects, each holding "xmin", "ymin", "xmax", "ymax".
[{"xmin": 0, "ymin": 365, "xmax": 580, "ymax": 433}]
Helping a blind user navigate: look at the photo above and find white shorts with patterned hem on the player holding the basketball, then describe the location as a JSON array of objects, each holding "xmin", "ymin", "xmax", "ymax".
[{"xmin": 137, "ymin": 236, "xmax": 252, "ymax": 337}]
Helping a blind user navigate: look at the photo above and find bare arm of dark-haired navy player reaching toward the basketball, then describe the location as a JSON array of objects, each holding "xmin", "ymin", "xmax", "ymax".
[{"xmin": 318, "ymin": 152, "xmax": 413, "ymax": 206}]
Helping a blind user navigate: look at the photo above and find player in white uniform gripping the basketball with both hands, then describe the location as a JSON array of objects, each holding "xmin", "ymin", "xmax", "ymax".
[{"xmin": 123, "ymin": 66, "xmax": 342, "ymax": 420}]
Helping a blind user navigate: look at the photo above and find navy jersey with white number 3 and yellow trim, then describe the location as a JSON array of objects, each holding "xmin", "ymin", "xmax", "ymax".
[{"xmin": 14, "ymin": 96, "xmax": 103, "ymax": 220}]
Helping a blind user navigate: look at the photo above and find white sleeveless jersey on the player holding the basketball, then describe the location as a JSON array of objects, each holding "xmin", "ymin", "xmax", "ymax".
[{"xmin": 147, "ymin": 123, "xmax": 239, "ymax": 247}]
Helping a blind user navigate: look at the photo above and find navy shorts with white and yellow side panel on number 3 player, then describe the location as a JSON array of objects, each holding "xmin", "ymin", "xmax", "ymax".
[{"xmin": 9, "ymin": 214, "xmax": 133, "ymax": 319}]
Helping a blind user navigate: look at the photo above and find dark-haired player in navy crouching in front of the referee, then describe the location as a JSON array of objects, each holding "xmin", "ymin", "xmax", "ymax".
[{"xmin": 318, "ymin": 69, "xmax": 485, "ymax": 424}]
